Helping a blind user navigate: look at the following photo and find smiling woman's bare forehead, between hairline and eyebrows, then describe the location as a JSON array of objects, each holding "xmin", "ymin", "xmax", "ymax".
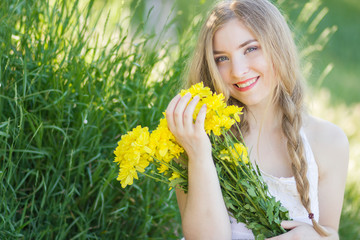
[{"xmin": 213, "ymin": 19, "xmax": 256, "ymax": 50}]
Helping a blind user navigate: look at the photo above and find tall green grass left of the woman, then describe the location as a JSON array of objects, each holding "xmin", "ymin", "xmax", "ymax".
[{"xmin": 0, "ymin": 0, "xmax": 191, "ymax": 239}]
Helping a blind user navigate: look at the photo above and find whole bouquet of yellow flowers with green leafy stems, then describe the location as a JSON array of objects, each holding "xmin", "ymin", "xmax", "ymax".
[{"xmin": 114, "ymin": 83, "xmax": 289, "ymax": 239}]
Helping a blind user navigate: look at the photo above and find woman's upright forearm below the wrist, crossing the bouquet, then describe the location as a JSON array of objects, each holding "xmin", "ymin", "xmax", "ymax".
[{"xmin": 183, "ymin": 153, "xmax": 231, "ymax": 240}]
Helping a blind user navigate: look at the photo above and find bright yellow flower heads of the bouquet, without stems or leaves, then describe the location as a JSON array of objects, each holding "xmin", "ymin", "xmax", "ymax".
[{"xmin": 114, "ymin": 82, "xmax": 247, "ymax": 187}]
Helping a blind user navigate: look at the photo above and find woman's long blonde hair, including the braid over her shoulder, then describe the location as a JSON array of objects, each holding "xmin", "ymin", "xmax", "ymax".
[{"xmin": 187, "ymin": 0, "xmax": 328, "ymax": 236}]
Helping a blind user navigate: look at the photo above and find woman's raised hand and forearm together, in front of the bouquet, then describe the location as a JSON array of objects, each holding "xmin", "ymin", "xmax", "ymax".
[{"xmin": 166, "ymin": 93, "xmax": 231, "ymax": 239}]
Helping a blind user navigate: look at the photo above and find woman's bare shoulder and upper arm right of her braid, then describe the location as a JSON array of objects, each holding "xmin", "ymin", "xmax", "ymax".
[{"xmin": 303, "ymin": 116, "xmax": 349, "ymax": 231}]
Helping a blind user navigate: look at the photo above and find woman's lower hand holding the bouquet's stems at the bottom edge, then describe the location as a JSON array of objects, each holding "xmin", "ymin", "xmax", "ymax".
[{"xmin": 268, "ymin": 221, "xmax": 322, "ymax": 240}]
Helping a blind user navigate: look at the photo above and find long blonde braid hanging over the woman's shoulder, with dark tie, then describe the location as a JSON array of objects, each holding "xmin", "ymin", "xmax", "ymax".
[{"xmin": 279, "ymin": 86, "xmax": 329, "ymax": 236}]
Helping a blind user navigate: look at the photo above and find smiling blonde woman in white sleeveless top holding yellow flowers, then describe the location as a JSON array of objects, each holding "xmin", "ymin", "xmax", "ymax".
[{"xmin": 166, "ymin": 0, "xmax": 348, "ymax": 240}]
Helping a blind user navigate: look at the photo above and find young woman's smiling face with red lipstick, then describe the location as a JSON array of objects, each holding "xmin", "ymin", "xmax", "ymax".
[{"xmin": 213, "ymin": 19, "xmax": 275, "ymax": 106}]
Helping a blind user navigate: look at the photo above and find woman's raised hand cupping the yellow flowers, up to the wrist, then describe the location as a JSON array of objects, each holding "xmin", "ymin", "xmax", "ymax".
[{"xmin": 166, "ymin": 93, "xmax": 211, "ymax": 159}]
